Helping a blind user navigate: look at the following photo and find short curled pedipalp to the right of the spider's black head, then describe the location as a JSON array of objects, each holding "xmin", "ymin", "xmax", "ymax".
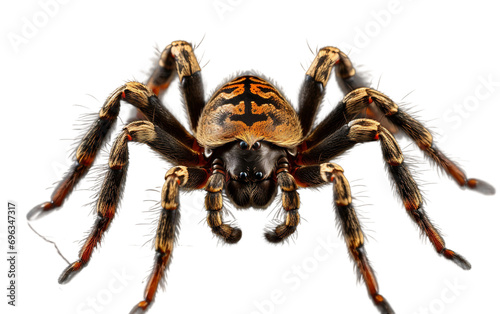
[{"xmin": 264, "ymin": 157, "xmax": 300, "ymax": 243}]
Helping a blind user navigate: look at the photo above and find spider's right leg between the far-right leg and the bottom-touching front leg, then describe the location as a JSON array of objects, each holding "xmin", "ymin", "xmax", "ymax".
[{"xmin": 299, "ymin": 119, "xmax": 470, "ymax": 269}]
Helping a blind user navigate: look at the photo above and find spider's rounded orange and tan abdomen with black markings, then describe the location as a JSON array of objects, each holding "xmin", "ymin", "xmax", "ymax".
[{"xmin": 196, "ymin": 75, "xmax": 302, "ymax": 148}]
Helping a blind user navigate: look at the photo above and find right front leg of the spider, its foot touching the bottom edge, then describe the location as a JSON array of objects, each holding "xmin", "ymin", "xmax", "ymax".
[{"xmin": 294, "ymin": 163, "xmax": 394, "ymax": 313}]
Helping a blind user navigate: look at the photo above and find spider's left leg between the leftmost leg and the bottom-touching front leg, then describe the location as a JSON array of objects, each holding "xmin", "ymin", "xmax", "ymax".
[{"xmin": 59, "ymin": 121, "xmax": 207, "ymax": 283}]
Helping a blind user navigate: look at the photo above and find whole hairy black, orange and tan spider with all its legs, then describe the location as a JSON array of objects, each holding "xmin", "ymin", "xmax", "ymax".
[{"xmin": 28, "ymin": 41, "xmax": 495, "ymax": 313}]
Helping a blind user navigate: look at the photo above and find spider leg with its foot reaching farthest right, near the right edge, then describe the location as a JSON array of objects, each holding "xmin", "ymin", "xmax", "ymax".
[{"xmin": 305, "ymin": 88, "xmax": 495, "ymax": 195}]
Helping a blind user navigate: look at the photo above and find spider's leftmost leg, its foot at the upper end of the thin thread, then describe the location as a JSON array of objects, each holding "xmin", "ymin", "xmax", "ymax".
[{"xmin": 27, "ymin": 82, "xmax": 196, "ymax": 219}]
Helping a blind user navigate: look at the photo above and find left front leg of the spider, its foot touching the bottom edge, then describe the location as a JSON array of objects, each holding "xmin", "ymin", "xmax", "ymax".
[{"xmin": 131, "ymin": 166, "xmax": 208, "ymax": 314}]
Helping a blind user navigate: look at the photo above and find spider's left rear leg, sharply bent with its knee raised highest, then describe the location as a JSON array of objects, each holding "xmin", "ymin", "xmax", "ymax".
[{"xmin": 147, "ymin": 40, "xmax": 205, "ymax": 131}]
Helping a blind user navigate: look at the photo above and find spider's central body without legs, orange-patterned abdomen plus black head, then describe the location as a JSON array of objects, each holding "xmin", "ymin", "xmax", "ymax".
[{"xmin": 196, "ymin": 75, "xmax": 302, "ymax": 207}]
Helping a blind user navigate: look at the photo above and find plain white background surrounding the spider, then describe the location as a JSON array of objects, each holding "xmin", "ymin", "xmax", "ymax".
[{"xmin": 0, "ymin": 0, "xmax": 500, "ymax": 314}]
